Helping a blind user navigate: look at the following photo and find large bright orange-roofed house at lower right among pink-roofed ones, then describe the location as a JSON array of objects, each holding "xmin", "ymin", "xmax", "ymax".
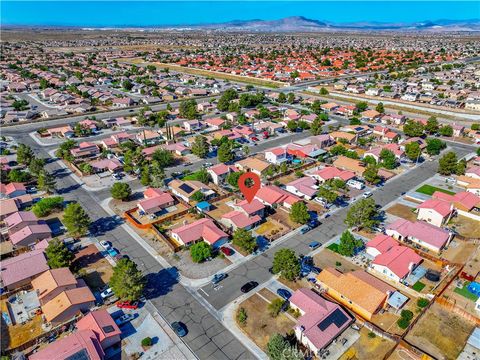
[{"xmin": 317, "ymin": 268, "xmax": 395, "ymax": 320}]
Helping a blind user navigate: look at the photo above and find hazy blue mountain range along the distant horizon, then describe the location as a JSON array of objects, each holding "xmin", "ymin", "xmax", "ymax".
[{"xmin": 187, "ymin": 16, "xmax": 480, "ymax": 32}]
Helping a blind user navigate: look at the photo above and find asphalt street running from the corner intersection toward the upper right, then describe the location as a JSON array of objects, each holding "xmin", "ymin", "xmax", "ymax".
[{"xmin": 198, "ymin": 144, "xmax": 472, "ymax": 310}]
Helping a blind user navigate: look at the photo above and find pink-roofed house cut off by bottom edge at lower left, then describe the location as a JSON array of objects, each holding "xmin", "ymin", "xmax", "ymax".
[{"xmin": 28, "ymin": 329, "xmax": 105, "ymax": 360}]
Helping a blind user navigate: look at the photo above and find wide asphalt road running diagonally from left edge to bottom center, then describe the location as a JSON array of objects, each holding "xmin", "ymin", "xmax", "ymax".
[{"xmin": 11, "ymin": 134, "xmax": 254, "ymax": 359}]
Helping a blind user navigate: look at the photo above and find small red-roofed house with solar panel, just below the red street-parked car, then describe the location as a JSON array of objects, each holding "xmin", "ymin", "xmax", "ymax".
[{"xmin": 76, "ymin": 309, "xmax": 122, "ymax": 350}]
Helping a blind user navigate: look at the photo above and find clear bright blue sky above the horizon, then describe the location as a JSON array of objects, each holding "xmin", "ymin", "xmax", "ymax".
[{"xmin": 1, "ymin": 0, "xmax": 480, "ymax": 26}]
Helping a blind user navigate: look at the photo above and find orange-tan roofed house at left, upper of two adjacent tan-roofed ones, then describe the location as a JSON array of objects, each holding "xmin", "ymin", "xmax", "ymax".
[{"xmin": 32, "ymin": 267, "xmax": 78, "ymax": 305}]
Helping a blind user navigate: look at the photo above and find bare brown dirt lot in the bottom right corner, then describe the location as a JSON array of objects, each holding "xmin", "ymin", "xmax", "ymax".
[{"xmin": 406, "ymin": 304, "xmax": 475, "ymax": 359}]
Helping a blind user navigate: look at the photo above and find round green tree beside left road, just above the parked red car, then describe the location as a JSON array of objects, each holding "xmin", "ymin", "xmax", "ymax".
[{"xmin": 109, "ymin": 258, "xmax": 145, "ymax": 301}]
